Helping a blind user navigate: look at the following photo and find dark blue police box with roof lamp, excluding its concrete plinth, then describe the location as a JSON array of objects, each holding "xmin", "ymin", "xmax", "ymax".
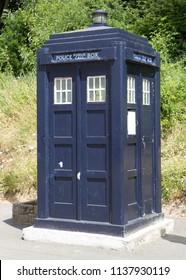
[{"xmin": 35, "ymin": 10, "xmax": 162, "ymax": 236}]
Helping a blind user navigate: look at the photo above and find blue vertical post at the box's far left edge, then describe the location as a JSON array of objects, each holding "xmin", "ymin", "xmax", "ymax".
[{"xmin": 37, "ymin": 51, "xmax": 49, "ymax": 218}]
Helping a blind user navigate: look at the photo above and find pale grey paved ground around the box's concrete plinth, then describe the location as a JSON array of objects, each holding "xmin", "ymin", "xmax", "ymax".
[{"xmin": 0, "ymin": 202, "xmax": 186, "ymax": 260}]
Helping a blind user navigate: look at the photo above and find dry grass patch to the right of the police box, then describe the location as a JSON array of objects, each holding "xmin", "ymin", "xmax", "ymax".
[{"xmin": 162, "ymin": 122, "xmax": 186, "ymax": 202}]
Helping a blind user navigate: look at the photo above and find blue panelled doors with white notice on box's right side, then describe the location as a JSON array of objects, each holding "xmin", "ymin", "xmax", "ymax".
[{"xmin": 126, "ymin": 65, "xmax": 154, "ymax": 221}]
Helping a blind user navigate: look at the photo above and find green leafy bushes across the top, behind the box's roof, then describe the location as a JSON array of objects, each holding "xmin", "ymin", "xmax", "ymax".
[{"xmin": 0, "ymin": 0, "xmax": 186, "ymax": 75}]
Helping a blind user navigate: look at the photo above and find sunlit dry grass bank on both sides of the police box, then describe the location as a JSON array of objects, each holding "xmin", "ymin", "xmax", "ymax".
[{"xmin": 0, "ymin": 73, "xmax": 186, "ymax": 205}]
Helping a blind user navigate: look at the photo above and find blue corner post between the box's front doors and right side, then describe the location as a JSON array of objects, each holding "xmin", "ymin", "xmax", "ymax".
[{"xmin": 111, "ymin": 42, "xmax": 127, "ymax": 225}]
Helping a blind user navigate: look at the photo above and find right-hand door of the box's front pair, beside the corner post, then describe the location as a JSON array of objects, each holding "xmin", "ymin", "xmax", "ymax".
[{"xmin": 81, "ymin": 62, "xmax": 110, "ymax": 222}]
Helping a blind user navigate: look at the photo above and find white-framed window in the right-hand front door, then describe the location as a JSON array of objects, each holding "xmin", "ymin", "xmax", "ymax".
[{"xmin": 87, "ymin": 76, "xmax": 106, "ymax": 102}]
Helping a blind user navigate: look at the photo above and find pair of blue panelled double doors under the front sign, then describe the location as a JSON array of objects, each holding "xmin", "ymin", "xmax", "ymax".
[{"xmin": 49, "ymin": 62, "xmax": 110, "ymax": 222}]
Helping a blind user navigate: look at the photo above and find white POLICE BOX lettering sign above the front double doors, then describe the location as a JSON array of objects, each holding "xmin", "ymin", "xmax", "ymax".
[{"xmin": 53, "ymin": 52, "xmax": 101, "ymax": 62}]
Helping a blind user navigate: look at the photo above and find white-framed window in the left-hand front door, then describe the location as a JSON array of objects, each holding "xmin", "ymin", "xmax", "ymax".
[{"xmin": 54, "ymin": 78, "xmax": 72, "ymax": 104}]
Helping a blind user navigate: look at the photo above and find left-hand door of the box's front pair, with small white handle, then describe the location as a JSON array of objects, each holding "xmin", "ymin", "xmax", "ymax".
[{"xmin": 48, "ymin": 65, "xmax": 77, "ymax": 219}]
